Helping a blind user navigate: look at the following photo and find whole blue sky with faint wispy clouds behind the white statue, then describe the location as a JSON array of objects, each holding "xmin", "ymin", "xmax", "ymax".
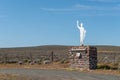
[{"xmin": 0, "ymin": 0, "xmax": 120, "ymax": 47}]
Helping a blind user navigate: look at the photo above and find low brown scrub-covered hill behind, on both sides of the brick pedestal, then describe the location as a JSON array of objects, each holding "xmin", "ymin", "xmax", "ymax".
[{"xmin": 0, "ymin": 45, "xmax": 120, "ymax": 62}]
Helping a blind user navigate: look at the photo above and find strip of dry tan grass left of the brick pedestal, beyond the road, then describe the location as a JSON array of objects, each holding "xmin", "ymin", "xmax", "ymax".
[{"xmin": 0, "ymin": 63, "xmax": 69, "ymax": 69}]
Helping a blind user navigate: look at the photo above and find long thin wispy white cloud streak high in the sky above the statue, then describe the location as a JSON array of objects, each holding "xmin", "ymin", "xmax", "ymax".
[{"xmin": 40, "ymin": 4, "xmax": 120, "ymax": 12}]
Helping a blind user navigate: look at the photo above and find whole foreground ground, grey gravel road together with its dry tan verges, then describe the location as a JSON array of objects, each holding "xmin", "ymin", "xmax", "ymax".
[{"xmin": 0, "ymin": 63, "xmax": 120, "ymax": 80}]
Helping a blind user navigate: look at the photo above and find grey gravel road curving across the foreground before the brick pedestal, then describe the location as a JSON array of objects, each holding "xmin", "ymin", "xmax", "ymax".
[{"xmin": 0, "ymin": 69, "xmax": 120, "ymax": 80}]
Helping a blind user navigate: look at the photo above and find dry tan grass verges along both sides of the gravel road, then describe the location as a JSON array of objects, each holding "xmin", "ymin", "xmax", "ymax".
[{"xmin": 0, "ymin": 63, "xmax": 120, "ymax": 76}]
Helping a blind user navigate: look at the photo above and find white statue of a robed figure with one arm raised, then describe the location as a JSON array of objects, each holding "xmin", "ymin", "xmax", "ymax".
[{"xmin": 77, "ymin": 20, "xmax": 86, "ymax": 45}]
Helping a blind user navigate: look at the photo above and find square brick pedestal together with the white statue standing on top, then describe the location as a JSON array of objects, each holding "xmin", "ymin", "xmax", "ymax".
[{"xmin": 69, "ymin": 21, "xmax": 97, "ymax": 70}]
